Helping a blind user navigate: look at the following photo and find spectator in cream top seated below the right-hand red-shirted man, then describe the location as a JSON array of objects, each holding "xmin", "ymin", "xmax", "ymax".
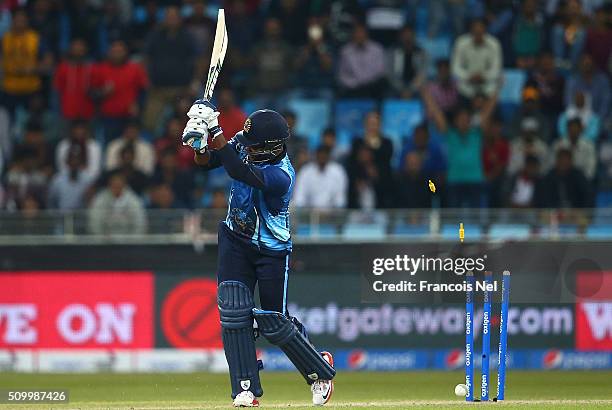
[{"xmin": 106, "ymin": 120, "xmax": 154, "ymax": 175}]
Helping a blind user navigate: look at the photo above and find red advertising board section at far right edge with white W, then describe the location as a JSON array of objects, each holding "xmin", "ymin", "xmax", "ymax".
[{"xmin": 576, "ymin": 271, "xmax": 612, "ymax": 351}]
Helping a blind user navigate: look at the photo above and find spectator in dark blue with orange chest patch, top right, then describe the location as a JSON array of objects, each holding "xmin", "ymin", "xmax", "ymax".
[{"xmin": 551, "ymin": 0, "xmax": 586, "ymax": 68}]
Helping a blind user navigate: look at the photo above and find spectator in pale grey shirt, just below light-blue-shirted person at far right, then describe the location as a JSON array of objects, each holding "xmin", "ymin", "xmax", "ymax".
[{"xmin": 553, "ymin": 117, "xmax": 597, "ymax": 181}]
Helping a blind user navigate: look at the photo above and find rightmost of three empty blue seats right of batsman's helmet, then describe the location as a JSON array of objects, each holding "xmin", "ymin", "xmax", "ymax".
[{"xmin": 382, "ymin": 100, "xmax": 423, "ymax": 153}]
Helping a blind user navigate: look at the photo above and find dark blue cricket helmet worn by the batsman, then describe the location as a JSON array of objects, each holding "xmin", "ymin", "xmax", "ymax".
[{"xmin": 236, "ymin": 110, "xmax": 290, "ymax": 164}]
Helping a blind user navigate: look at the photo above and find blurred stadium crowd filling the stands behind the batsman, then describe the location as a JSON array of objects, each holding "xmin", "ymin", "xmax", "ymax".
[{"xmin": 0, "ymin": 0, "xmax": 612, "ymax": 231}]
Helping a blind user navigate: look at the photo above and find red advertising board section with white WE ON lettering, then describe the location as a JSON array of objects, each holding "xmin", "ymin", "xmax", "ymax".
[{"xmin": 0, "ymin": 271, "xmax": 154, "ymax": 348}]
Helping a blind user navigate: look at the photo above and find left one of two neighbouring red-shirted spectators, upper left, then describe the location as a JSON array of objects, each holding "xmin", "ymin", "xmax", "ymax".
[{"xmin": 53, "ymin": 38, "xmax": 94, "ymax": 120}]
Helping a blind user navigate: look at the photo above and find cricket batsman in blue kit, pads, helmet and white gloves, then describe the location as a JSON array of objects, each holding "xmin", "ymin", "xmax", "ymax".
[{"xmin": 182, "ymin": 99, "xmax": 336, "ymax": 407}]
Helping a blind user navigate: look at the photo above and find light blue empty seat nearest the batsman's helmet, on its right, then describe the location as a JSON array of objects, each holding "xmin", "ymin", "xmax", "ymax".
[{"xmin": 287, "ymin": 98, "xmax": 331, "ymax": 148}]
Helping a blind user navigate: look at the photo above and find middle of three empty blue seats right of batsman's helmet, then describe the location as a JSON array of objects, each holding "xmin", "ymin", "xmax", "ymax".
[{"xmin": 335, "ymin": 100, "xmax": 376, "ymax": 148}]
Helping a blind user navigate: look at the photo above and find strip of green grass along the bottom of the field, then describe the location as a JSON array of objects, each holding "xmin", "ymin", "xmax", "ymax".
[{"xmin": 0, "ymin": 371, "xmax": 612, "ymax": 409}]
